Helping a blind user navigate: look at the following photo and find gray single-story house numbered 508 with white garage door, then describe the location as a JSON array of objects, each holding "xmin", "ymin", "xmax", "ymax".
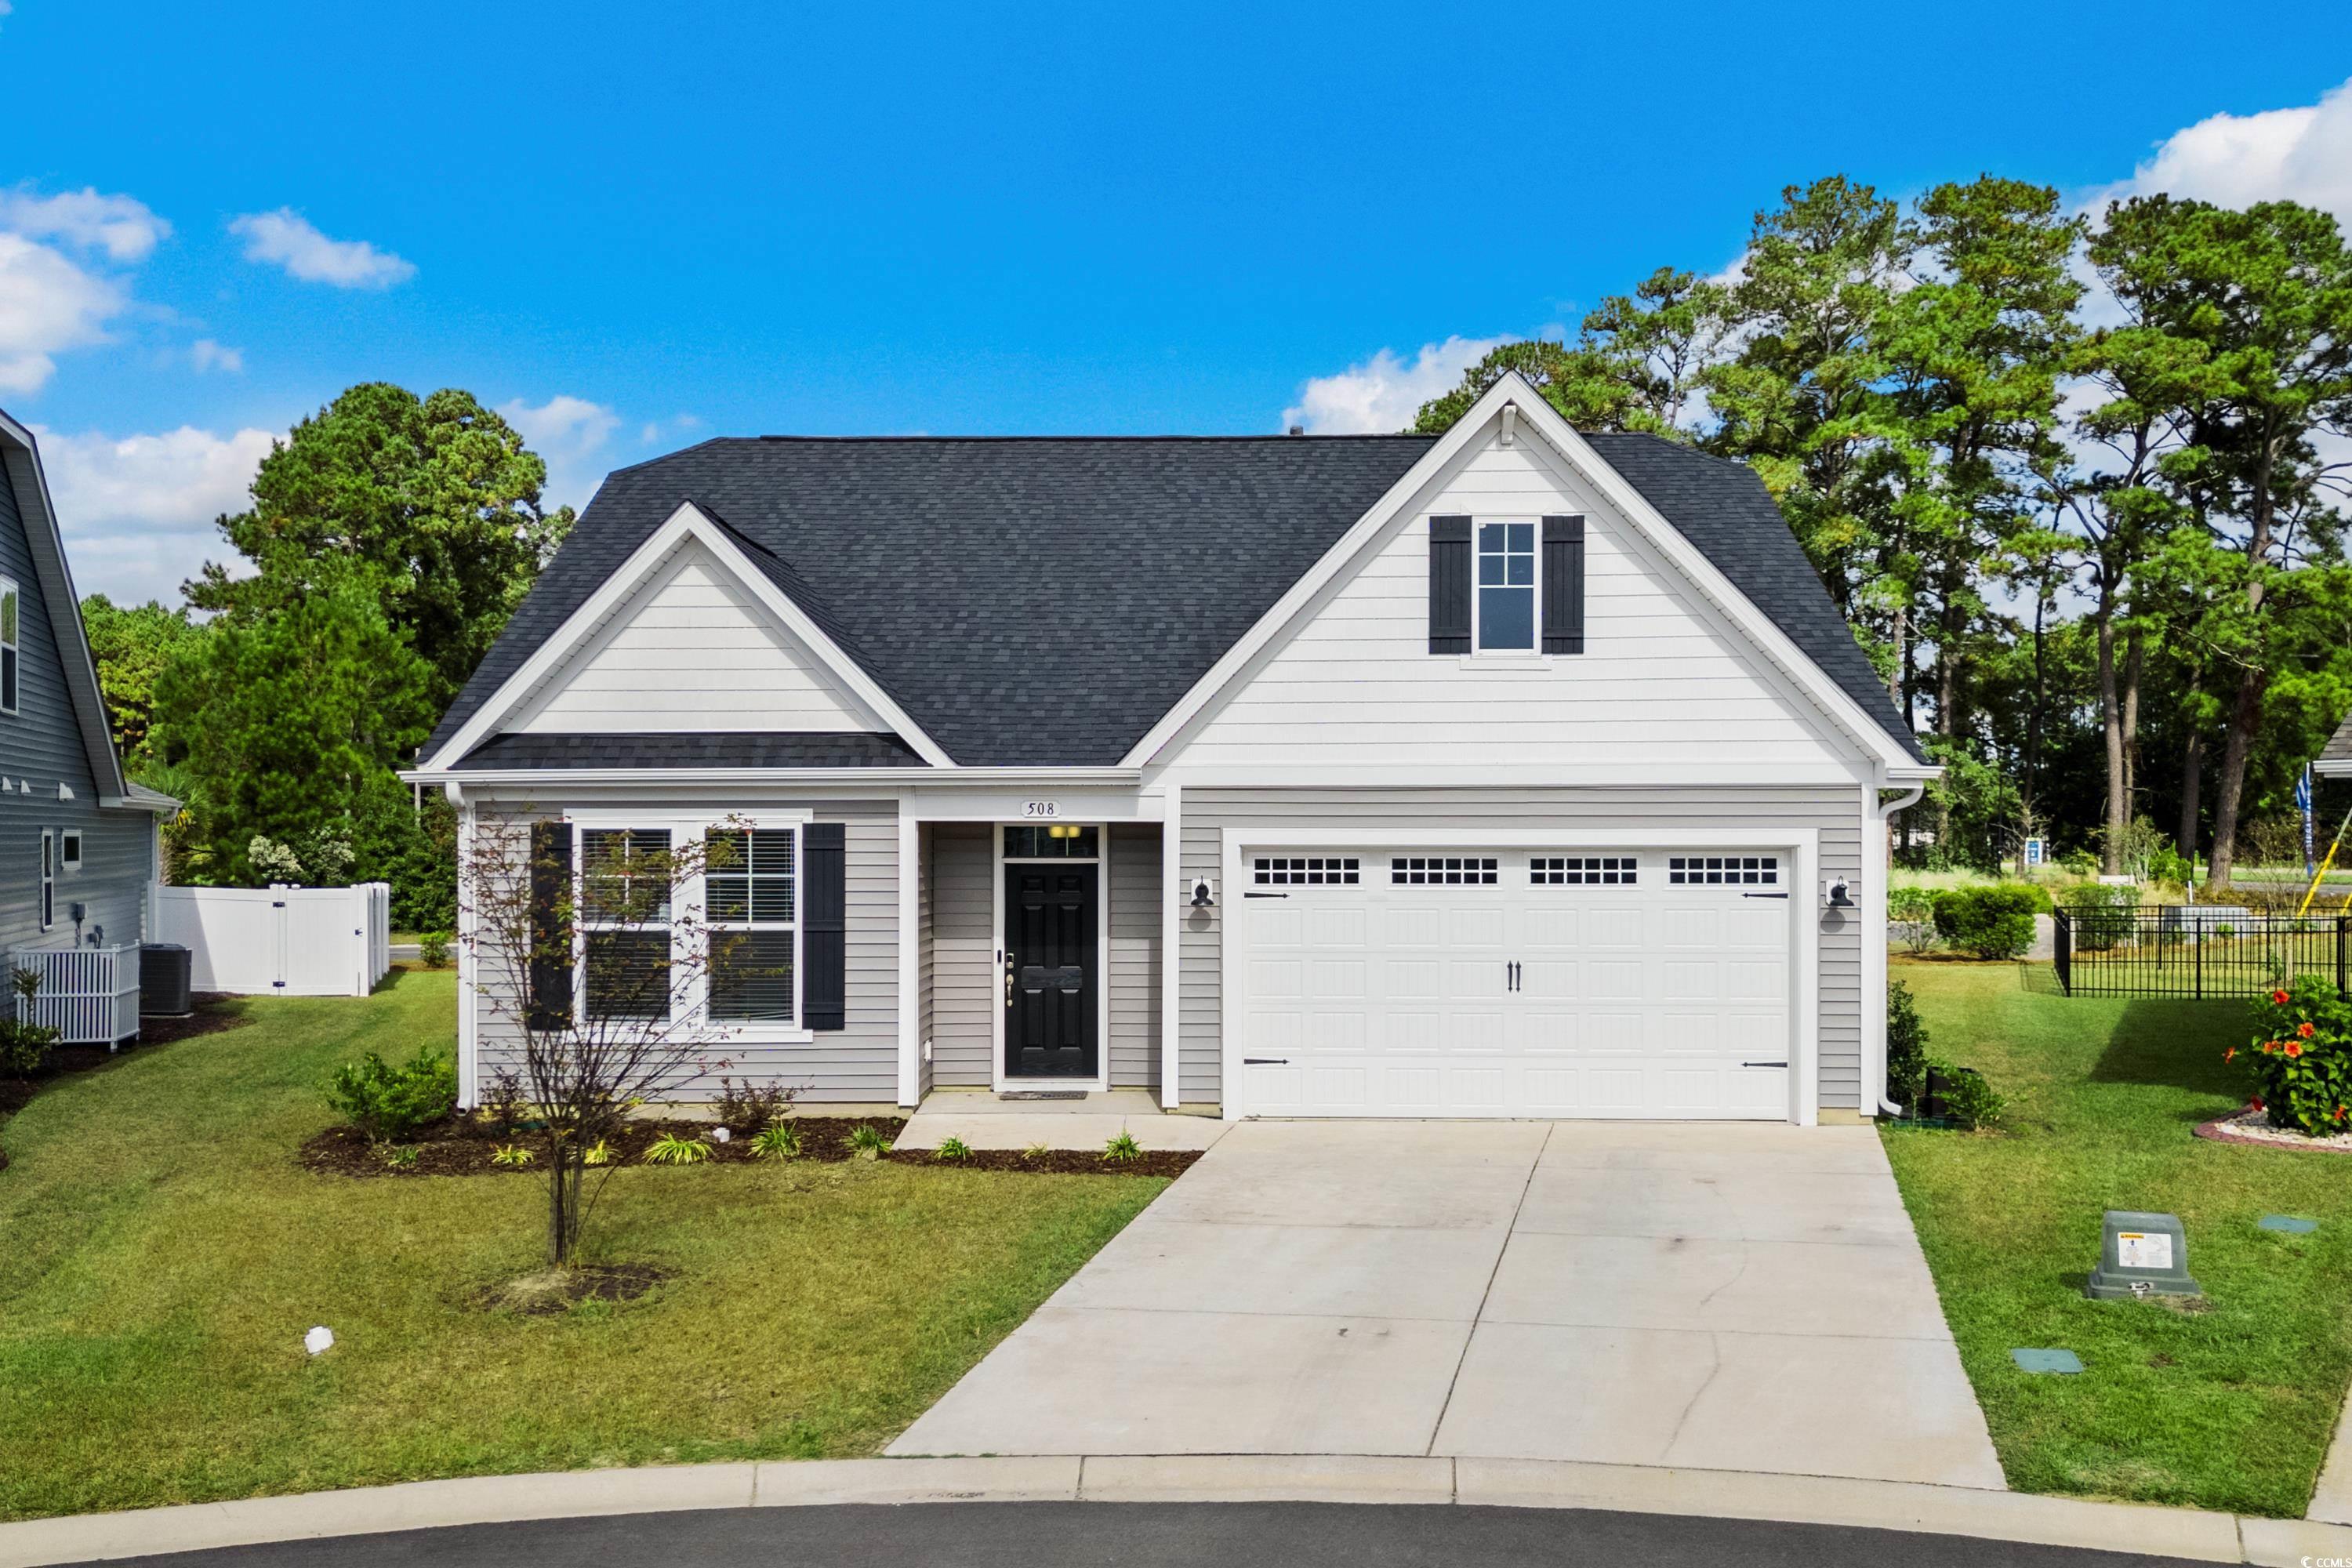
[{"xmin": 412, "ymin": 376, "xmax": 1936, "ymax": 1123}]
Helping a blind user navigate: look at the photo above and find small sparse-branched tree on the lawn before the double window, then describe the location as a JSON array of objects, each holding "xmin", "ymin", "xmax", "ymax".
[{"xmin": 459, "ymin": 820, "xmax": 741, "ymax": 1267}]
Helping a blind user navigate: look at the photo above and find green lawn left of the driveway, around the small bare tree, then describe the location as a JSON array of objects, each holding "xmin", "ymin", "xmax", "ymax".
[{"xmin": 0, "ymin": 971, "xmax": 1167, "ymax": 1519}]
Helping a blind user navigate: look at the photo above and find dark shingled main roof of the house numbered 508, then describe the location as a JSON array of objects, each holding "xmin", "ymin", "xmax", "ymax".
[{"xmin": 423, "ymin": 423, "xmax": 1919, "ymax": 767}]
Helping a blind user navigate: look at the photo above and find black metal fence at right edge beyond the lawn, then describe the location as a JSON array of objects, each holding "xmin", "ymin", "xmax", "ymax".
[{"xmin": 2051, "ymin": 905, "xmax": 2352, "ymax": 999}]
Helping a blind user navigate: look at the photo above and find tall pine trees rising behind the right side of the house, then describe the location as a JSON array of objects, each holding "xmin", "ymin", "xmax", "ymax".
[{"xmin": 1416, "ymin": 176, "xmax": 2352, "ymax": 881}]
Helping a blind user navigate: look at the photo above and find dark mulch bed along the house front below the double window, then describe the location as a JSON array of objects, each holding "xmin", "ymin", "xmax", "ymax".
[{"xmin": 301, "ymin": 1114, "xmax": 1200, "ymax": 1175}]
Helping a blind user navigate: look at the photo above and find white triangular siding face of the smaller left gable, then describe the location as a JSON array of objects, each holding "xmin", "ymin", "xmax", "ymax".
[{"xmin": 501, "ymin": 536, "xmax": 889, "ymax": 734}]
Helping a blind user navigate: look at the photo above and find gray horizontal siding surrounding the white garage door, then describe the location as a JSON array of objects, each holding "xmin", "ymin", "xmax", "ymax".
[{"xmin": 1181, "ymin": 785, "xmax": 1867, "ymax": 1109}]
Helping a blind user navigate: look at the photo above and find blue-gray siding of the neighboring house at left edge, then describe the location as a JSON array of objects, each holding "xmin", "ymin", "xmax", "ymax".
[{"xmin": 0, "ymin": 446, "xmax": 155, "ymax": 952}]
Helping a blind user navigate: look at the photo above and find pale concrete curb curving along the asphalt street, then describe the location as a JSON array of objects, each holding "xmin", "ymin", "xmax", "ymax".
[{"xmin": 0, "ymin": 1455, "xmax": 2352, "ymax": 1568}]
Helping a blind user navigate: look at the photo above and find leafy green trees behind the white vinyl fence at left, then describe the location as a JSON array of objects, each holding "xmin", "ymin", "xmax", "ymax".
[{"xmin": 82, "ymin": 383, "xmax": 572, "ymax": 931}]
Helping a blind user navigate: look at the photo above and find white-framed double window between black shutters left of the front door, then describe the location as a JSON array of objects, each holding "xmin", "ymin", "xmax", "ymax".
[{"xmin": 572, "ymin": 811, "xmax": 807, "ymax": 1041}]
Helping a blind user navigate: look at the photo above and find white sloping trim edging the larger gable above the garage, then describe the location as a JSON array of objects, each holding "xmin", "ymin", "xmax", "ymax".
[{"xmin": 1122, "ymin": 372, "xmax": 1940, "ymax": 779}]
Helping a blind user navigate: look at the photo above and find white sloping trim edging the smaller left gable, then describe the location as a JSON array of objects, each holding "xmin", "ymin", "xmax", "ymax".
[{"xmin": 416, "ymin": 501, "xmax": 955, "ymax": 776}]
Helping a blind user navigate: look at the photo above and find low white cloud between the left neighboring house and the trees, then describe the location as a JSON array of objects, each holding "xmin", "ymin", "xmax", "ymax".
[{"xmin": 33, "ymin": 426, "xmax": 275, "ymax": 604}]
